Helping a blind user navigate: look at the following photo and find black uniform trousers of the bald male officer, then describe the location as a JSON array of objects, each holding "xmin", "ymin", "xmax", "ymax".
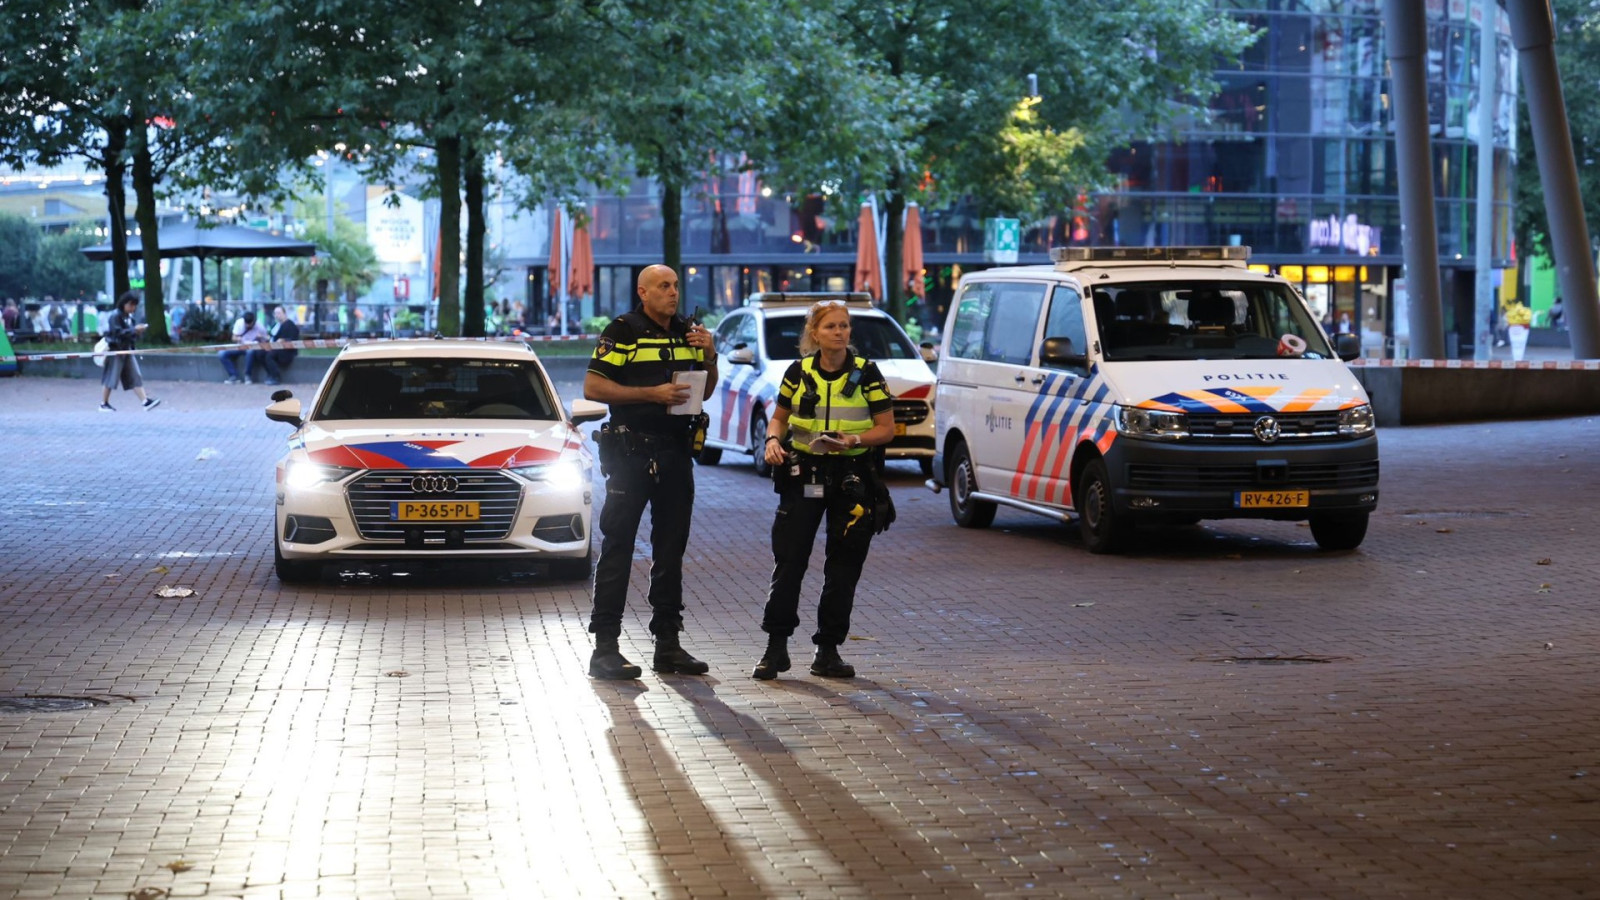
[{"xmin": 589, "ymin": 436, "xmax": 694, "ymax": 637}]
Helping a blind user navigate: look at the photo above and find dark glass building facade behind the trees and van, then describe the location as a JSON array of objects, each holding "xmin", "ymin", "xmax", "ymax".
[{"xmin": 528, "ymin": 0, "xmax": 1517, "ymax": 357}]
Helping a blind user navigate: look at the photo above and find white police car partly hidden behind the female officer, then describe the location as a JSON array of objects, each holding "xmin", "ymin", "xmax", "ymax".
[{"xmin": 699, "ymin": 293, "xmax": 934, "ymax": 477}]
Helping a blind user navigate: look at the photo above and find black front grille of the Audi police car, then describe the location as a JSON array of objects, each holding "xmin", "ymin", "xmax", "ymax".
[{"xmin": 346, "ymin": 469, "xmax": 522, "ymax": 538}]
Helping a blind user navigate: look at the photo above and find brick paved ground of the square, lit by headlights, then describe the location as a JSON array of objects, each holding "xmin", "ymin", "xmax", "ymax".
[{"xmin": 0, "ymin": 378, "xmax": 1600, "ymax": 900}]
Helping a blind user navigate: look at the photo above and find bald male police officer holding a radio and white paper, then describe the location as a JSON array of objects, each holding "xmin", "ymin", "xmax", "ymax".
[{"xmin": 584, "ymin": 266, "xmax": 717, "ymax": 679}]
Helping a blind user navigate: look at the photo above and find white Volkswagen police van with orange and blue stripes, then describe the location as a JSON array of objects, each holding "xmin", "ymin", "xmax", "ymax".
[{"xmin": 928, "ymin": 247, "xmax": 1378, "ymax": 552}]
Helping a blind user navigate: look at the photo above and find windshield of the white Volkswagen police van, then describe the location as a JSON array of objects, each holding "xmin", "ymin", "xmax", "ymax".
[{"xmin": 1094, "ymin": 282, "xmax": 1334, "ymax": 362}]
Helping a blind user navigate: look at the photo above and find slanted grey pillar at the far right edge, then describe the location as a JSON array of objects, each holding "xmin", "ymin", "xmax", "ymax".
[{"xmin": 1506, "ymin": 0, "xmax": 1600, "ymax": 359}]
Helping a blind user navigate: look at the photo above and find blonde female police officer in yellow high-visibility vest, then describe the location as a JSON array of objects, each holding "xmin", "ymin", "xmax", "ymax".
[{"xmin": 750, "ymin": 301, "xmax": 894, "ymax": 681}]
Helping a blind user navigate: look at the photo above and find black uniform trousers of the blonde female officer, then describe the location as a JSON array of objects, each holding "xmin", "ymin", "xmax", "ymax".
[{"xmin": 762, "ymin": 464, "xmax": 872, "ymax": 647}]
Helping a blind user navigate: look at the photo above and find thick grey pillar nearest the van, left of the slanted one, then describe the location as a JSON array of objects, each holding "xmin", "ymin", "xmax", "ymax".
[{"xmin": 1384, "ymin": 0, "xmax": 1445, "ymax": 359}]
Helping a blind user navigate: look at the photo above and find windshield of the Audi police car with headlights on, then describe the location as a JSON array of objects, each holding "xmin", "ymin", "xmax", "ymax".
[{"xmin": 312, "ymin": 359, "xmax": 560, "ymax": 420}]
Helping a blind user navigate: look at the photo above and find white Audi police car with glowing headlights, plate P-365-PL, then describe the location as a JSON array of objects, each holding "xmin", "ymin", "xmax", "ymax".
[{"xmin": 266, "ymin": 340, "xmax": 606, "ymax": 581}]
